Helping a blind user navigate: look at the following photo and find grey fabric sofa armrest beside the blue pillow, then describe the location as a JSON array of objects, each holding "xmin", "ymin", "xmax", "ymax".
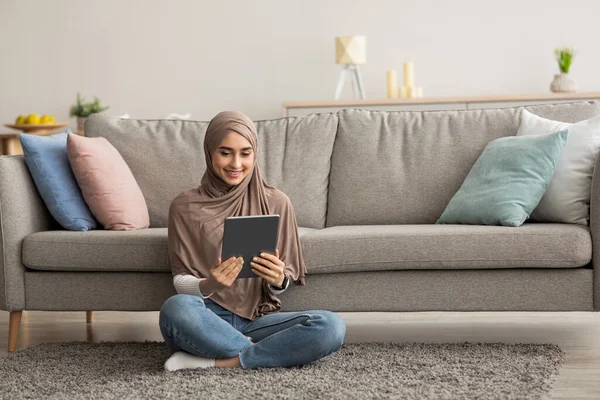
[{"xmin": 0, "ymin": 156, "xmax": 56, "ymax": 311}]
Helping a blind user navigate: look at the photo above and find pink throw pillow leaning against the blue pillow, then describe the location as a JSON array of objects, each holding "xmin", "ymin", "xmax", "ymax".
[{"xmin": 67, "ymin": 133, "xmax": 150, "ymax": 231}]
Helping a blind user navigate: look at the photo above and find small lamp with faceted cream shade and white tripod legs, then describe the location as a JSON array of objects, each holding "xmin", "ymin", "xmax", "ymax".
[{"xmin": 335, "ymin": 36, "xmax": 367, "ymax": 100}]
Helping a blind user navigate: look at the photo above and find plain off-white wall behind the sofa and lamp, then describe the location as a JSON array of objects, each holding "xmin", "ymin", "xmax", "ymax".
[{"xmin": 0, "ymin": 0, "xmax": 600, "ymax": 126}]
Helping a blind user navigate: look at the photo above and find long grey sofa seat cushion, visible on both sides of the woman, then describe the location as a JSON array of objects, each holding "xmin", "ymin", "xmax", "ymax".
[{"xmin": 23, "ymin": 224, "xmax": 592, "ymax": 274}]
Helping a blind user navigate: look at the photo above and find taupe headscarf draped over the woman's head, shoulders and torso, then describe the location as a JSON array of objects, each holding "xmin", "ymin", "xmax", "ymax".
[{"xmin": 168, "ymin": 111, "xmax": 306, "ymax": 320}]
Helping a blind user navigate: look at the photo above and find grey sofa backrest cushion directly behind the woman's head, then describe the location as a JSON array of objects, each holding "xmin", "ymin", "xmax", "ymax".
[{"xmin": 85, "ymin": 113, "xmax": 338, "ymax": 228}]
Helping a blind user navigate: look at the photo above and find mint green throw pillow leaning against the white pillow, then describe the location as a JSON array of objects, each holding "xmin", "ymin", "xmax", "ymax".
[{"xmin": 436, "ymin": 130, "xmax": 568, "ymax": 226}]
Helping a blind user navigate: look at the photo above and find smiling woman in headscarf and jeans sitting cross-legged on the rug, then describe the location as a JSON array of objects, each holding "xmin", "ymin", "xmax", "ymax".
[{"xmin": 159, "ymin": 111, "xmax": 346, "ymax": 371}]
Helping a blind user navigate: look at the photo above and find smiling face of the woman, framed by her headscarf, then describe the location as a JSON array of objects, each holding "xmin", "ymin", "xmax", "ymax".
[{"xmin": 212, "ymin": 131, "xmax": 254, "ymax": 186}]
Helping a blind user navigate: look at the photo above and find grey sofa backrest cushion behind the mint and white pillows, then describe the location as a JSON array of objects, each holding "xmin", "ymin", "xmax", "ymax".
[{"xmin": 326, "ymin": 102, "xmax": 600, "ymax": 226}]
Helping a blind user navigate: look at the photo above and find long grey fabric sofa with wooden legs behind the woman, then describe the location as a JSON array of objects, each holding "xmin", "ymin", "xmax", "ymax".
[{"xmin": 0, "ymin": 102, "xmax": 600, "ymax": 351}]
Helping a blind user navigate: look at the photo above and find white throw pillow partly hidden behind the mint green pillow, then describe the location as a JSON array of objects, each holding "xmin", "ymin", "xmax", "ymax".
[{"xmin": 517, "ymin": 110, "xmax": 600, "ymax": 225}]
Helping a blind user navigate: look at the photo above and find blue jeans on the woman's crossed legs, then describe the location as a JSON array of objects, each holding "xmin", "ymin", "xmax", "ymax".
[{"xmin": 159, "ymin": 294, "xmax": 346, "ymax": 368}]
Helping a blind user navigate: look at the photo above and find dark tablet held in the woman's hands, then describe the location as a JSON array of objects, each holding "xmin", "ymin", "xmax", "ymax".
[{"xmin": 221, "ymin": 214, "xmax": 279, "ymax": 278}]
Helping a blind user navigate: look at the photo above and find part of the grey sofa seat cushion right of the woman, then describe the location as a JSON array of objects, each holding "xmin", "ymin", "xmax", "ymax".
[{"xmin": 302, "ymin": 223, "xmax": 592, "ymax": 274}]
